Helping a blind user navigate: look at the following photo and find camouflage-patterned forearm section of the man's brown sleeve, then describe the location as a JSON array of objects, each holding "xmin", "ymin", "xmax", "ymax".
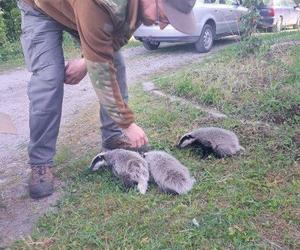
[{"xmin": 86, "ymin": 60, "xmax": 133, "ymax": 127}]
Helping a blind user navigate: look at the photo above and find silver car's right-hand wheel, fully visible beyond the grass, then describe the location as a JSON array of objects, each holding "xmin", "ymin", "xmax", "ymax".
[{"xmin": 195, "ymin": 24, "xmax": 214, "ymax": 53}]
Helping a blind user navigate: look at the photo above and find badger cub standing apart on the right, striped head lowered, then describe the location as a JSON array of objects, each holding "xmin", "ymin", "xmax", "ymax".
[{"xmin": 178, "ymin": 127, "xmax": 245, "ymax": 158}]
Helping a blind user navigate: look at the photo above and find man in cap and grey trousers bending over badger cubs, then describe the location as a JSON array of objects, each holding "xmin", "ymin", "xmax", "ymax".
[{"xmin": 19, "ymin": 0, "xmax": 196, "ymax": 198}]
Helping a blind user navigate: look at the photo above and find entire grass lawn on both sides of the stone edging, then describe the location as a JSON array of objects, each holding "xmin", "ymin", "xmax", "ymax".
[{"xmin": 12, "ymin": 31, "xmax": 300, "ymax": 249}]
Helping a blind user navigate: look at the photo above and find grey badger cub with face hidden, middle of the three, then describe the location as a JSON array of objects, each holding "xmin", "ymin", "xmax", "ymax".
[{"xmin": 144, "ymin": 151, "xmax": 195, "ymax": 194}]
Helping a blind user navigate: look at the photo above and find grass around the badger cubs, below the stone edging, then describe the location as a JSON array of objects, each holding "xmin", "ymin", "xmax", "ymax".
[{"xmin": 14, "ymin": 91, "xmax": 300, "ymax": 249}]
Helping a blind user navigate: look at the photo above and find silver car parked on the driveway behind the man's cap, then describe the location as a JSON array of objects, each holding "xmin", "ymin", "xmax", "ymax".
[{"xmin": 133, "ymin": 0, "xmax": 248, "ymax": 53}]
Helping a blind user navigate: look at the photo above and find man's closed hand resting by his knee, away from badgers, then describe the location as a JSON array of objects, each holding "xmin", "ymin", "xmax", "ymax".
[{"xmin": 65, "ymin": 58, "xmax": 87, "ymax": 85}]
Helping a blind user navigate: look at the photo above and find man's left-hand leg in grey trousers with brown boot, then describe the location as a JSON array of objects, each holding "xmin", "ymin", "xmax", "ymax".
[{"xmin": 19, "ymin": 2, "xmax": 65, "ymax": 198}]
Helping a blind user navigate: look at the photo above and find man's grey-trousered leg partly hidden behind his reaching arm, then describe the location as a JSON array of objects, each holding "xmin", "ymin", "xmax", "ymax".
[{"xmin": 100, "ymin": 51, "xmax": 128, "ymax": 148}]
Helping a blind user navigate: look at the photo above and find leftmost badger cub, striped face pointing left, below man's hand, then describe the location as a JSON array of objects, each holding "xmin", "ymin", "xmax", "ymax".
[{"xmin": 90, "ymin": 149, "xmax": 149, "ymax": 194}]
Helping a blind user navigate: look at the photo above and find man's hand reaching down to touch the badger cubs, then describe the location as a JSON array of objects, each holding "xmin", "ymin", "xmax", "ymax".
[{"xmin": 124, "ymin": 123, "xmax": 148, "ymax": 148}]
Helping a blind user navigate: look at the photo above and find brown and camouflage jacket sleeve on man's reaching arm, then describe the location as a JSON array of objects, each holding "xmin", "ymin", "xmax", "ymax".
[{"xmin": 74, "ymin": 1, "xmax": 134, "ymax": 128}]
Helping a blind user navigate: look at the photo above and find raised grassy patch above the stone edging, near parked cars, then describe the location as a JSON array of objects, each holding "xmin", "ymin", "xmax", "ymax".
[{"xmin": 154, "ymin": 33, "xmax": 300, "ymax": 124}]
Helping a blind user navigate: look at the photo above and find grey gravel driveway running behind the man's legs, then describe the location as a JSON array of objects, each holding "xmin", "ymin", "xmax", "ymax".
[{"xmin": 0, "ymin": 38, "xmax": 234, "ymax": 248}]
